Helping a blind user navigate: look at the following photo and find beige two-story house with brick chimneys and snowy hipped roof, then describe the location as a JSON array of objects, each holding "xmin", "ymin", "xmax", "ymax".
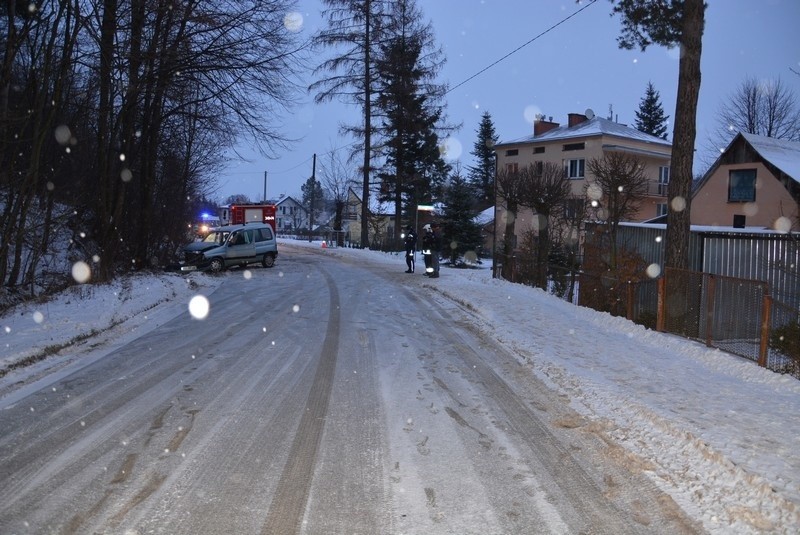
[{"xmin": 495, "ymin": 110, "xmax": 672, "ymax": 249}]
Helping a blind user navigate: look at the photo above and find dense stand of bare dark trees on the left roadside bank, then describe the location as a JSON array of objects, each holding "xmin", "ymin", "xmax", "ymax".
[{"xmin": 0, "ymin": 0, "xmax": 305, "ymax": 285}]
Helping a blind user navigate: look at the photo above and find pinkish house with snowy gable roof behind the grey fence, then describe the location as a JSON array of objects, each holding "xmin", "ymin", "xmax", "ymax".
[{"xmin": 691, "ymin": 133, "xmax": 800, "ymax": 232}]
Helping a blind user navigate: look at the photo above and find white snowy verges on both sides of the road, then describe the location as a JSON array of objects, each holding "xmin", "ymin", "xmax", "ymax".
[{"xmin": 0, "ymin": 241, "xmax": 800, "ymax": 534}]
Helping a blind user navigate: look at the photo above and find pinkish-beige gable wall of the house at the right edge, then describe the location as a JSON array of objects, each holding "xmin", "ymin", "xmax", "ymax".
[{"xmin": 690, "ymin": 162, "xmax": 800, "ymax": 231}]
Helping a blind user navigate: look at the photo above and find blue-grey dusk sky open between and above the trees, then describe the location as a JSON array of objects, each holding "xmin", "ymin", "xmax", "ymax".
[{"xmin": 218, "ymin": 0, "xmax": 800, "ymax": 201}]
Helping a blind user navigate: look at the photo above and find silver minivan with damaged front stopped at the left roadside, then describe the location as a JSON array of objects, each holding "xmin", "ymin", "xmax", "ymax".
[{"xmin": 180, "ymin": 223, "xmax": 278, "ymax": 273}]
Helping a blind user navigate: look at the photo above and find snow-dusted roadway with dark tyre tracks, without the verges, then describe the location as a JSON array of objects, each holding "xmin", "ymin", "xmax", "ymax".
[{"xmin": 0, "ymin": 247, "xmax": 701, "ymax": 534}]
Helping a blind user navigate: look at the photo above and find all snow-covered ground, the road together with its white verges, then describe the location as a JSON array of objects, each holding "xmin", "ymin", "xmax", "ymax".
[{"xmin": 0, "ymin": 243, "xmax": 800, "ymax": 533}]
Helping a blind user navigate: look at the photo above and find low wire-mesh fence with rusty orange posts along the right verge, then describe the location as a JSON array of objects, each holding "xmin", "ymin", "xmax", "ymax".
[{"xmin": 495, "ymin": 258, "xmax": 800, "ymax": 379}]
